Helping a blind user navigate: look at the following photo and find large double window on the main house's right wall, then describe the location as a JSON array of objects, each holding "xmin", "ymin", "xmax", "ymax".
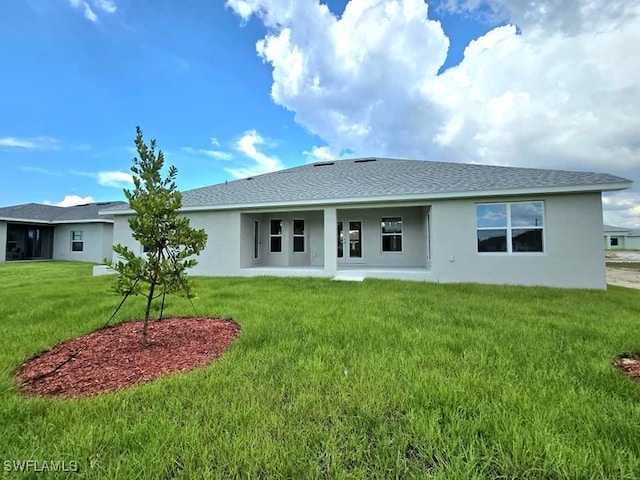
[{"xmin": 476, "ymin": 202, "xmax": 544, "ymax": 253}]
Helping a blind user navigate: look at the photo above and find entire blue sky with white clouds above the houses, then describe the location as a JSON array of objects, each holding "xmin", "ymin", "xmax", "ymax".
[{"xmin": 0, "ymin": 0, "xmax": 640, "ymax": 226}]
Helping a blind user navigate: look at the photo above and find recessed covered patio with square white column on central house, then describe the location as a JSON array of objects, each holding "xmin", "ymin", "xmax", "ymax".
[{"xmin": 240, "ymin": 205, "xmax": 431, "ymax": 280}]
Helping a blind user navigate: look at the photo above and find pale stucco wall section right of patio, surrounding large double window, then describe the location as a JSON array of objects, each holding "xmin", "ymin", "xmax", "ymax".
[{"xmin": 431, "ymin": 193, "xmax": 606, "ymax": 289}]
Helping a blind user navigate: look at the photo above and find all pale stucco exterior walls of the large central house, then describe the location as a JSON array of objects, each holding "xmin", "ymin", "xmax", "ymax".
[{"xmin": 109, "ymin": 193, "xmax": 606, "ymax": 289}]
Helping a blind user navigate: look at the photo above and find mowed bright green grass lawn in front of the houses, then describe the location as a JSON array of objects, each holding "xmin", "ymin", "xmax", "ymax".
[{"xmin": 0, "ymin": 263, "xmax": 640, "ymax": 479}]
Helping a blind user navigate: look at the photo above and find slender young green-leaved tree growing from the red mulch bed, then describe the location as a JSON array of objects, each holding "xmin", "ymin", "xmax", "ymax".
[{"xmin": 107, "ymin": 126, "xmax": 207, "ymax": 347}]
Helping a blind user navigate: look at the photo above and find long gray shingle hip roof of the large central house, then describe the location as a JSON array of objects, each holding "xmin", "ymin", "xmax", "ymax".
[{"xmin": 102, "ymin": 158, "xmax": 631, "ymax": 213}]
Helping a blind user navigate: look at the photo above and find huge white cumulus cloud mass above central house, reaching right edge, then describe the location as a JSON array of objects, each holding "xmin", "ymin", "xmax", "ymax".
[{"xmin": 227, "ymin": 0, "xmax": 640, "ymax": 223}]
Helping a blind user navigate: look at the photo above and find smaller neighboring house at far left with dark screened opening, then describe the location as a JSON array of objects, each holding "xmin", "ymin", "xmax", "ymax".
[{"xmin": 0, "ymin": 202, "xmax": 127, "ymax": 263}]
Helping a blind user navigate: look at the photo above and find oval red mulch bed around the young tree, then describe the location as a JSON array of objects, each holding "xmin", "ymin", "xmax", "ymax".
[{"xmin": 16, "ymin": 318, "xmax": 240, "ymax": 397}]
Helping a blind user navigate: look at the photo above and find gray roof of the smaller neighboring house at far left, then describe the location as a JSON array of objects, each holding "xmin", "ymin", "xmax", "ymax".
[{"xmin": 0, "ymin": 202, "xmax": 128, "ymax": 223}]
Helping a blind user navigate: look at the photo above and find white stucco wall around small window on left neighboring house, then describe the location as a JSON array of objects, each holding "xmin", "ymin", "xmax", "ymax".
[{"xmin": 53, "ymin": 223, "xmax": 113, "ymax": 263}]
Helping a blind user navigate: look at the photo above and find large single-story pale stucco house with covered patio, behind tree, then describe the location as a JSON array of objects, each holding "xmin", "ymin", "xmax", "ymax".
[{"xmin": 104, "ymin": 158, "xmax": 631, "ymax": 289}]
